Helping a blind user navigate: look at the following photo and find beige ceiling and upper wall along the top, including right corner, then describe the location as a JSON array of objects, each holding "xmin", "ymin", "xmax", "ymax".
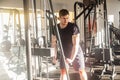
[{"xmin": 0, "ymin": 0, "xmax": 120, "ymax": 26}]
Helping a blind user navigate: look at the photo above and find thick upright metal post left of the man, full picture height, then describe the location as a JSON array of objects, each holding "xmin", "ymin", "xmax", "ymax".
[{"xmin": 23, "ymin": 0, "xmax": 33, "ymax": 80}]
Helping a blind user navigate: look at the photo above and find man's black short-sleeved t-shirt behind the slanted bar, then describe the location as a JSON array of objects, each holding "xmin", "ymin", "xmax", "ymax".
[{"xmin": 53, "ymin": 22, "xmax": 79, "ymax": 58}]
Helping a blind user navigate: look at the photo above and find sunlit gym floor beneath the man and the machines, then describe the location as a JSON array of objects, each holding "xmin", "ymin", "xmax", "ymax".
[{"xmin": 0, "ymin": 47, "xmax": 120, "ymax": 80}]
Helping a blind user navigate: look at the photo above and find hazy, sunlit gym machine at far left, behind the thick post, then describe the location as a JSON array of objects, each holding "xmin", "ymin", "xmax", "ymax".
[{"xmin": 0, "ymin": 8, "xmax": 26, "ymax": 79}]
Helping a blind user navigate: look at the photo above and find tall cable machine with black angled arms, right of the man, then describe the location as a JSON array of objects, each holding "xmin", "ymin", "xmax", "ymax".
[{"xmin": 74, "ymin": 0, "xmax": 115, "ymax": 80}]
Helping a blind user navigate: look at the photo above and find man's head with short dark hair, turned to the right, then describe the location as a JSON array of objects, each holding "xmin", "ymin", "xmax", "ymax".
[{"xmin": 59, "ymin": 9, "xmax": 69, "ymax": 25}]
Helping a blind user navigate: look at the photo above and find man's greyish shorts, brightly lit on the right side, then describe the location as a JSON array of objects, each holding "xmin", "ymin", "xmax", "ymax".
[{"xmin": 60, "ymin": 48, "xmax": 85, "ymax": 71}]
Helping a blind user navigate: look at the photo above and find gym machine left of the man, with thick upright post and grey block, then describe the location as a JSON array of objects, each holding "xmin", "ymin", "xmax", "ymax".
[{"xmin": 23, "ymin": 0, "xmax": 64, "ymax": 80}]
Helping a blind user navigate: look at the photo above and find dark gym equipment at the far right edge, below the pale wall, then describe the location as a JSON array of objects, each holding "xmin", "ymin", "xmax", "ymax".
[{"xmin": 110, "ymin": 25, "xmax": 120, "ymax": 65}]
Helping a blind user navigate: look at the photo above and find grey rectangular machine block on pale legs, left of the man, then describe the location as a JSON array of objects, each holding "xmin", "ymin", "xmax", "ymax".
[{"xmin": 32, "ymin": 48, "xmax": 55, "ymax": 80}]
